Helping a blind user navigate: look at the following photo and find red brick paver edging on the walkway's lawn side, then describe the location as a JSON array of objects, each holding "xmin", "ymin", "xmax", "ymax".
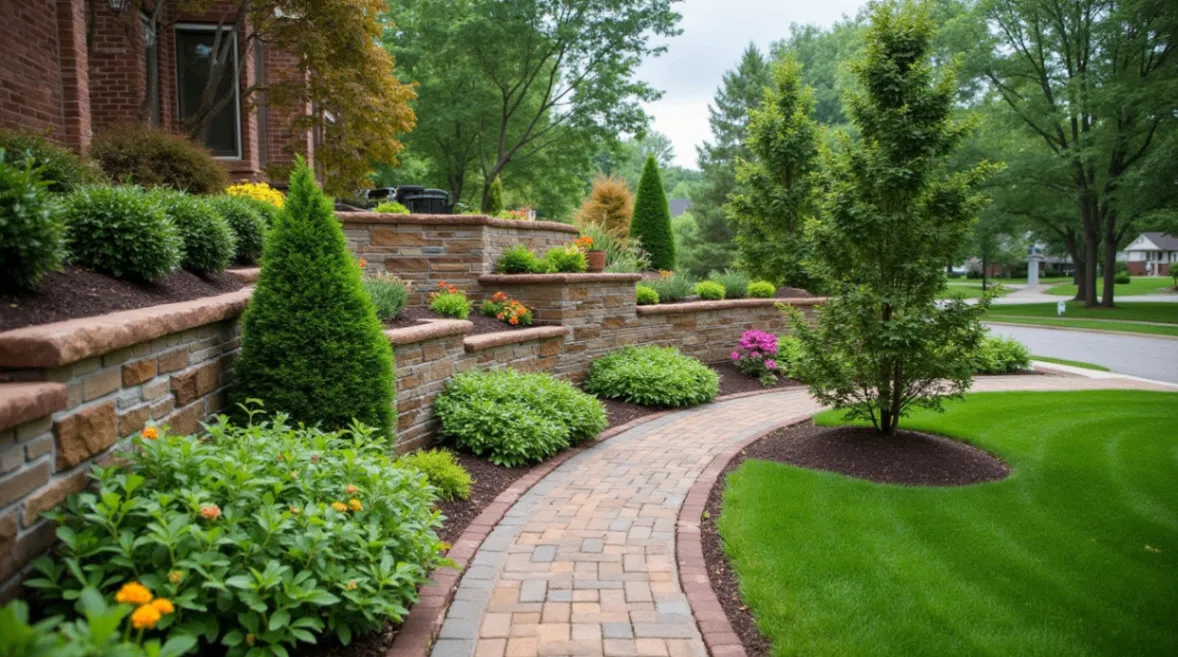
[{"xmin": 675, "ymin": 416, "xmax": 816, "ymax": 657}]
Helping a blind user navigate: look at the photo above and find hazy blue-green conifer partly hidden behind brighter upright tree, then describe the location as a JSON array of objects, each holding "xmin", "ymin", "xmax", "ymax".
[{"xmin": 680, "ymin": 44, "xmax": 769, "ymax": 277}]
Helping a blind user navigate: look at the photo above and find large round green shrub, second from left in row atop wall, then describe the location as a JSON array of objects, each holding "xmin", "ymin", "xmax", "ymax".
[{"xmin": 61, "ymin": 187, "xmax": 183, "ymax": 280}]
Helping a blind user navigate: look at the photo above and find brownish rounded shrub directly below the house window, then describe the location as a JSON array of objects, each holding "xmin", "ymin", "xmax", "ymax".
[{"xmin": 90, "ymin": 125, "xmax": 229, "ymax": 194}]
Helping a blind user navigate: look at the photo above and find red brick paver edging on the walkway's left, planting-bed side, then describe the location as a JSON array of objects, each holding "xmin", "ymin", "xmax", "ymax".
[{"xmin": 386, "ymin": 387, "xmax": 791, "ymax": 657}]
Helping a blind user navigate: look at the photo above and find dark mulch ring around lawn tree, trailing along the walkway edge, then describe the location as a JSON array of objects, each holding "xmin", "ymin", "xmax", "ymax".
[{"xmin": 700, "ymin": 423, "xmax": 1011, "ymax": 657}]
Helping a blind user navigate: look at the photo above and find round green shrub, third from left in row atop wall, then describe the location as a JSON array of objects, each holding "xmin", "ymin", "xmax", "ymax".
[{"xmin": 152, "ymin": 190, "xmax": 237, "ymax": 273}]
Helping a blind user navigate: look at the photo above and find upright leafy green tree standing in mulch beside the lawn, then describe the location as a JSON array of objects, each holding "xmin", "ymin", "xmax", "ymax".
[{"xmin": 794, "ymin": 2, "xmax": 993, "ymax": 434}]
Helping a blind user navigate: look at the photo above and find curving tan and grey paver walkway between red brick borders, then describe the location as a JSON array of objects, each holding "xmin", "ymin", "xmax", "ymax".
[{"xmin": 432, "ymin": 376, "xmax": 1172, "ymax": 657}]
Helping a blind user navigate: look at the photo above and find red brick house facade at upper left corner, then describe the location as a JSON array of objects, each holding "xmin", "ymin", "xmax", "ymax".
[{"xmin": 0, "ymin": 0, "xmax": 320, "ymax": 181}]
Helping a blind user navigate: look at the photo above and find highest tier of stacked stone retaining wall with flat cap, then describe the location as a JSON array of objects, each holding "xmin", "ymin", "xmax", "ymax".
[{"xmin": 337, "ymin": 212, "xmax": 577, "ymax": 304}]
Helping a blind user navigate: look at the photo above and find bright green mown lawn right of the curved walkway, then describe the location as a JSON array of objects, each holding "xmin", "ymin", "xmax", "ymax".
[{"xmin": 719, "ymin": 392, "xmax": 1178, "ymax": 657}]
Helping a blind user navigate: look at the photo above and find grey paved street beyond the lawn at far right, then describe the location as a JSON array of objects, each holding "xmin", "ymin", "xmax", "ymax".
[{"xmin": 988, "ymin": 324, "xmax": 1178, "ymax": 383}]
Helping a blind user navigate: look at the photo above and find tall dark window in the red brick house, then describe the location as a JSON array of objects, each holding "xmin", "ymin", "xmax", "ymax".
[{"xmin": 176, "ymin": 25, "xmax": 241, "ymax": 159}]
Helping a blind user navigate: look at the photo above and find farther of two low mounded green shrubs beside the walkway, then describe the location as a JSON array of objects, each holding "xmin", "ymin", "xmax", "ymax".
[{"xmin": 584, "ymin": 346, "xmax": 720, "ymax": 407}]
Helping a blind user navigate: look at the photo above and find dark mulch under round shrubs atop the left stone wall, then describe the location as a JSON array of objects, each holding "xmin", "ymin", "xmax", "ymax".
[{"xmin": 0, "ymin": 267, "xmax": 244, "ymax": 331}]
